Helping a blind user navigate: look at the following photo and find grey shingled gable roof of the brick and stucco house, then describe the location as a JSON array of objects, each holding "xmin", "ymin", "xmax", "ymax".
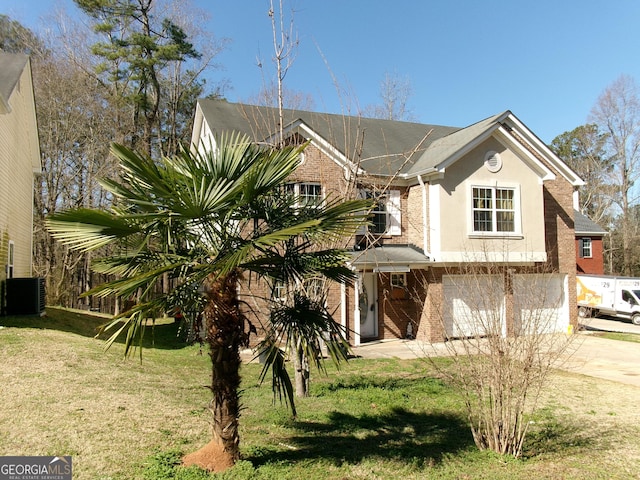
[{"xmin": 194, "ymin": 99, "xmax": 584, "ymax": 186}]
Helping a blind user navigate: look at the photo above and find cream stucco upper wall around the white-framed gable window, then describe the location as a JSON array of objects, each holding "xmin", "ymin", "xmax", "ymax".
[{"xmin": 429, "ymin": 138, "xmax": 546, "ymax": 263}]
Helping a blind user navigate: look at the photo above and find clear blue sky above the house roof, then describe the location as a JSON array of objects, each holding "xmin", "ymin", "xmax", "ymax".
[{"xmin": 5, "ymin": 0, "xmax": 640, "ymax": 142}]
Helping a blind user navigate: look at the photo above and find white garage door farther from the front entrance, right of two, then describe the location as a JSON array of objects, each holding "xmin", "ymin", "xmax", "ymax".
[{"xmin": 513, "ymin": 274, "xmax": 569, "ymax": 333}]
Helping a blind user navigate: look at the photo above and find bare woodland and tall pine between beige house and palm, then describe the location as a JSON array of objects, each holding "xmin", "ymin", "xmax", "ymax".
[{"xmin": 0, "ymin": 0, "xmax": 224, "ymax": 312}]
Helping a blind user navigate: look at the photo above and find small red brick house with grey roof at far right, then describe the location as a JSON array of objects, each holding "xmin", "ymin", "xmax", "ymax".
[{"xmin": 574, "ymin": 210, "xmax": 608, "ymax": 275}]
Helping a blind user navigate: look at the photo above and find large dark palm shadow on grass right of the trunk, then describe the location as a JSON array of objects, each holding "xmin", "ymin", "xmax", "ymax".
[{"xmin": 247, "ymin": 408, "xmax": 473, "ymax": 468}]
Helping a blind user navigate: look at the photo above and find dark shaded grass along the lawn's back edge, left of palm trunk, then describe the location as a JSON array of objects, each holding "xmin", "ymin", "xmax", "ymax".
[{"xmin": 0, "ymin": 307, "xmax": 188, "ymax": 350}]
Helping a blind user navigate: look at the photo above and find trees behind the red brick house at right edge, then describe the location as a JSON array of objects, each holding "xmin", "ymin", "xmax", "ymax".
[{"xmin": 551, "ymin": 75, "xmax": 640, "ymax": 276}]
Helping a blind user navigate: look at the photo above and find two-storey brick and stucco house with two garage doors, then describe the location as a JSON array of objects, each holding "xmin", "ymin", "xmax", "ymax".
[{"xmin": 192, "ymin": 99, "xmax": 583, "ymax": 345}]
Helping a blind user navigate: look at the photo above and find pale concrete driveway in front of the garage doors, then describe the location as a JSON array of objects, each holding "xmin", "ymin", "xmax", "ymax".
[{"xmin": 353, "ymin": 319, "xmax": 640, "ymax": 387}]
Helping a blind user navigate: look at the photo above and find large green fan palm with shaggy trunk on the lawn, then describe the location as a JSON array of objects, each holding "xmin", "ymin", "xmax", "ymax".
[{"xmin": 48, "ymin": 134, "xmax": 370, "ymax": 468}]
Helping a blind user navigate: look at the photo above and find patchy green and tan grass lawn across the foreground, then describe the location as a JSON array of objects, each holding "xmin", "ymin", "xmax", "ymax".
[{"xmin": 0, "ymin": 309, "xmax": 640, "ymax": 480}]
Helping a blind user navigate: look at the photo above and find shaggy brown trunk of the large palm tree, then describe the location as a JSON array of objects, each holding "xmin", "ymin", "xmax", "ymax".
[{"xmin": 204, "ymin": 271, "xmax": 246, "ymax": 463}]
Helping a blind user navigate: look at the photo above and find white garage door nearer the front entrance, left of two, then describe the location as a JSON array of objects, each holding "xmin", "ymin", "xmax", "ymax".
[{"xmin": 442, "ymin": 275, "xmax": 505, "ymax": 338}]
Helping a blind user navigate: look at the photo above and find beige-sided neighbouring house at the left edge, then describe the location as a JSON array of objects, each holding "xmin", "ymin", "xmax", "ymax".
[{"xmin": 0, "ymin": 51, "xmax": 41, "ymax": 283}]
